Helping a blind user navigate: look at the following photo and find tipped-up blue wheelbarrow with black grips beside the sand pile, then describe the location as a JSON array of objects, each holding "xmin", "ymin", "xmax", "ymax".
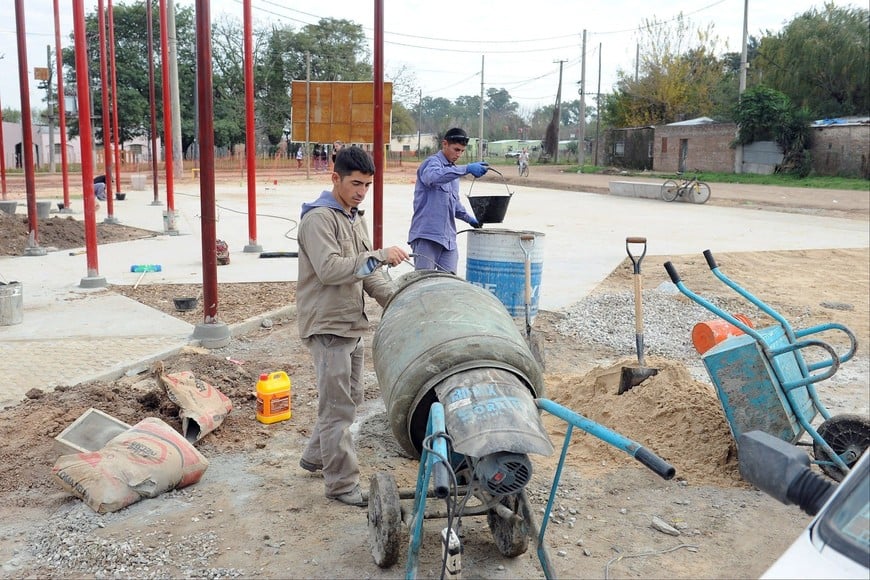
[{"xmin": 665, "ymin": 250, "xmax": 870, "ymax": 481}]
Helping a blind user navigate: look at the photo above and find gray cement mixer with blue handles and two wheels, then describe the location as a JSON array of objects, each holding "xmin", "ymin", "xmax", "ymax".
[{"xmin": 367, "ymin": 270, "xmax": 675, "ymax": 578}]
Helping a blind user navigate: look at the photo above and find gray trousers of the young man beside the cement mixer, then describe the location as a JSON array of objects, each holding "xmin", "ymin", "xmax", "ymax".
[{"xmin": 302, "ymin": 334, "xmax": 365, "ymax": 497}]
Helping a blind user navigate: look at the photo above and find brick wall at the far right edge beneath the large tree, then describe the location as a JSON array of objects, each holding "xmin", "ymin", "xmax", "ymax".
[{"xmin": 810, "ymin": 124, "xmax": 870, "ymax": 179}]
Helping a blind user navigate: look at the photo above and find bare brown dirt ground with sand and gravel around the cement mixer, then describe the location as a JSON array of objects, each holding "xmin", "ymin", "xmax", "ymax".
[{"xmin": 0, "ymin": 167, "xmax": 870, "ymax": 578}]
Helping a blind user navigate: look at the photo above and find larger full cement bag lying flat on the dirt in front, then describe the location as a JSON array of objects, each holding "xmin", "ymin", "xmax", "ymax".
[{"xmin": 51, "ymin": 417, "xmax": 208, "ymax": 514}]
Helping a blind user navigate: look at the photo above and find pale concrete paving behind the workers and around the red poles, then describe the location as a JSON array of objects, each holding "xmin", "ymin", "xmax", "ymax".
[{"xmin": 0, "ymin": 175, "xmax": 870, "ymax": 404}]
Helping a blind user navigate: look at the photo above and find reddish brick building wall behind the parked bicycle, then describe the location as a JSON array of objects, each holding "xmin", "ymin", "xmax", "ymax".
[{"xmin": 653, "ymin": 123, "xmax": 737, "ymax": 173}]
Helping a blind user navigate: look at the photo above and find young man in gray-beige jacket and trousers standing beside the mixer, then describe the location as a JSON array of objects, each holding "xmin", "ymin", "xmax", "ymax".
[{"xmin": 296, "ymin": 147, "xmax": 408, "ymax": 505}]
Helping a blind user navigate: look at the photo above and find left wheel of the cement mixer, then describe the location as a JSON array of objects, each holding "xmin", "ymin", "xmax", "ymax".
[{"xmin": 368, "ymin": 472, "xmax": 402, "ymax": 568}]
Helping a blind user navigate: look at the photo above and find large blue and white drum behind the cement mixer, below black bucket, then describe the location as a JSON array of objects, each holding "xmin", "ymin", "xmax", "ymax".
[{"xmin": 465, "ymin": 228, "xmax": 544, "ymax": 318}]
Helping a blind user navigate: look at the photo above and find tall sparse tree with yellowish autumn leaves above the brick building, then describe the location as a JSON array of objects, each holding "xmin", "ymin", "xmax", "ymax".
[{"xmin": 603, "ymin": 14, "xmax": 723, "ymax": 127}]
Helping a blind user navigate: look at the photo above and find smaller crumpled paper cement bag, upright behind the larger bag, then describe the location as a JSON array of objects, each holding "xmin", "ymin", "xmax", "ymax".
[{"xmin": 158, "ymin": 368, "xmax": 233, "ymax": 443}]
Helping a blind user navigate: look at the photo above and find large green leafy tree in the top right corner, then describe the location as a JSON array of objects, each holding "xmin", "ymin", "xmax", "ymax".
[{"xmin": 757, "ymin": 3, "xmax": 870, "ymax": 117}]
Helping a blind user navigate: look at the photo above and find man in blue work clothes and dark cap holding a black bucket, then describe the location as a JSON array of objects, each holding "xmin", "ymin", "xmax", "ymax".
[{"xmin": 408, "ymin": 127, "xmax": 489, "ymax": 274}]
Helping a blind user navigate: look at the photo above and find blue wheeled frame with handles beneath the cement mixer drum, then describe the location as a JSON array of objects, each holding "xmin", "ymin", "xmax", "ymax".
[{"xmin": 367, "ymin": 399, "xmax": 676, "ymax": 579}]
